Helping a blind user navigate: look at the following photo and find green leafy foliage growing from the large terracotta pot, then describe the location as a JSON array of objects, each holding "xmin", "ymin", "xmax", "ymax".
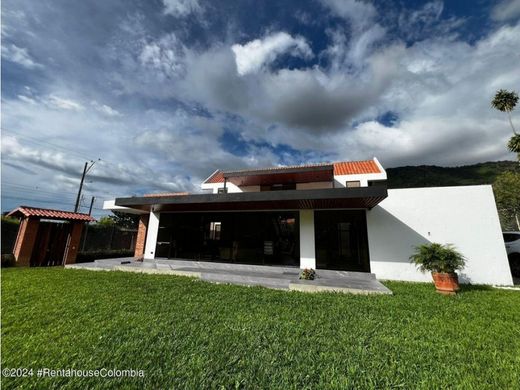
[{"xmin": 410, "ymin": 243, "xmax": 466, "ymax": 273}]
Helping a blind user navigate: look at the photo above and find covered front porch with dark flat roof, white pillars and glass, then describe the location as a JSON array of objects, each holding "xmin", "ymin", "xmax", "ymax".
[{"xmin": 111, "ymin": 186, "xmax": 387, "ymax": 272}]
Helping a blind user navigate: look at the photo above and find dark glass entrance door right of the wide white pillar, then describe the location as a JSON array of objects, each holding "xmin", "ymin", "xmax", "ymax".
[{"xmin": 314, "ymin": 210, "xmax": 370, "ymax": 272}]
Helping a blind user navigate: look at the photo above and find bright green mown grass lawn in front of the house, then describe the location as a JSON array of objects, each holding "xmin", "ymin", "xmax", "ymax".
[{"xmin": 1, "ymin": 268, "xmax": 520, "ymax": 389}]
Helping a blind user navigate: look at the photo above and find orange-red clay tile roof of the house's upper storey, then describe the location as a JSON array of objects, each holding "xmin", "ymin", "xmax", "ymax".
[{"xmin": 204, "ymin": 160, "xmax": 381, "ymax": 184}]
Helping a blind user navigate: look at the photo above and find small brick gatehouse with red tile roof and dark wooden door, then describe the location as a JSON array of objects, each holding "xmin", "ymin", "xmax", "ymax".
[{"xmin": 8, "ymin": 206, "xmax": 95, "ymax": 267}]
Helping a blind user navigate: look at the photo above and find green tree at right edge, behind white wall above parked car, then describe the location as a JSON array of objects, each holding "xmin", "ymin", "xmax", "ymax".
[{"xmin": 493, "ymin": 171, "xmax": 520, "ymax": 230}]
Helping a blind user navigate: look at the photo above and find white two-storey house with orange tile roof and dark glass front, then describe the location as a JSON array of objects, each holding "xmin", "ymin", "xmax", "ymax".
[{"xmin": 104, "ymin": 158, "xmax": 512, "ymax": 285}]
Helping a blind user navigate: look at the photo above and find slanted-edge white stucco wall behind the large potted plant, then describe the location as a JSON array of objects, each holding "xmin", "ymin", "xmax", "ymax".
[{"xmin": 367, "ymin": 185, "xmax": 513, "ymax": 285}]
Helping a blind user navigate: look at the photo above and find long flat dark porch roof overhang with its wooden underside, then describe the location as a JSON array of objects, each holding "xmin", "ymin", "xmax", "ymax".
[{"xmin": 115, "ymin": 186, "xmax": 388, "ymax": 212}]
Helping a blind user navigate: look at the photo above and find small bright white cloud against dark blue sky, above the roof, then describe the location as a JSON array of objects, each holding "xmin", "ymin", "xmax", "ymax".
[{"xmin": 231, "ymin": 32, "xmax": 313, "ymax": 76}]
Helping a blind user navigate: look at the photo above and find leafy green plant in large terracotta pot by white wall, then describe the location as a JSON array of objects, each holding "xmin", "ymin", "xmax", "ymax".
[{"xmin": 410, "ymin": 243, "xmax": 466, "ymax": 295}]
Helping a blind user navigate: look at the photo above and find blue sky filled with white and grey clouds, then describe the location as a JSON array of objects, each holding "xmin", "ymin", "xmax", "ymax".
[{"xmin": 2, "ymin": 0, "xmax": 520, "ymax": 216}]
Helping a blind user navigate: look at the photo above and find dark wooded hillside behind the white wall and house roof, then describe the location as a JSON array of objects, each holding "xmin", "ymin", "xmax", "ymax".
[{"xmin": 386, "ymin": 161, "xmax": 519, "ymax": 188}]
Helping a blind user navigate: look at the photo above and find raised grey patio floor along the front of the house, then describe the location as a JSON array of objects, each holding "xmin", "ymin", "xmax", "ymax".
[{"xmin": 65, "ymin": 257, "xmax": 392, "ymax": 294}]
